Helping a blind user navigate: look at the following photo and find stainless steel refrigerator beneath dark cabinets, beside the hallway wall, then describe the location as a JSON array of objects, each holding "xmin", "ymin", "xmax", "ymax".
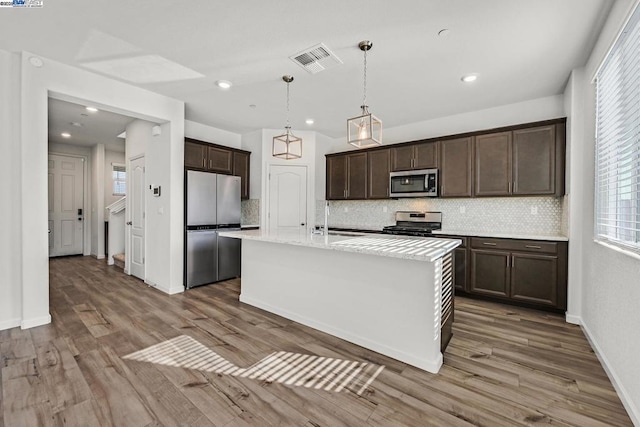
[{"xmin": 184, "ymin": 171, "xmax": 240, "ymax": 289}]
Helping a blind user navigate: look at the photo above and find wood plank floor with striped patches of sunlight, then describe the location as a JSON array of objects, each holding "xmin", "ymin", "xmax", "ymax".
[{"xmin": 0, "ymin": 257, "xmax": 632, "ymax": 427}]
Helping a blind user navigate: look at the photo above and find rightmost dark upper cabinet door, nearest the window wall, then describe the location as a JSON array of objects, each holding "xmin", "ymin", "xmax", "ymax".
[{"xmin": 513, "ymin": 125, "xmax": 556, "ymax": 195}]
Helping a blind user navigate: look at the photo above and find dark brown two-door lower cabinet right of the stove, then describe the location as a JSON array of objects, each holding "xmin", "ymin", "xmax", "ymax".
[{"xmin": 467, "ymin": 237, "xmax": 568, "ymax": 311}]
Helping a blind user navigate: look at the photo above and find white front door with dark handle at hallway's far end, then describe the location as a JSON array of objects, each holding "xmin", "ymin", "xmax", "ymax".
[{"xmin": 49, "ymin": 154, "xmax": 84, "ymax": 257}]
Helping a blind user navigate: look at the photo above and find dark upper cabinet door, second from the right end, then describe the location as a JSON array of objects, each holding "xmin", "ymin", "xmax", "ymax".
[{"xmin": 474, "ymin": 132, "xmax": 511, "ymax": 196}]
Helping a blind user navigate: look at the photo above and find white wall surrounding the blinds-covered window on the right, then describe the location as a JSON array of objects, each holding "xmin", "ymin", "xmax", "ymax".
[{"xmin": 565, "ymin": 0, "xmax": 640, "ymax": 425}]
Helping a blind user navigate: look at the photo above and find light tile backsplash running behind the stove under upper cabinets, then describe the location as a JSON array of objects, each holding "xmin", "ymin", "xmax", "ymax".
[{"xmin": 316, "ymin": 196, "xmax": 568, "ymax": 236}]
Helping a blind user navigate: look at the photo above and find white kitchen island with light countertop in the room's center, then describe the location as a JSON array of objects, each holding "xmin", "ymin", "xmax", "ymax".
[{"xmin": 220, "ymin": 230, "xmax": 460, "ymax": 373}]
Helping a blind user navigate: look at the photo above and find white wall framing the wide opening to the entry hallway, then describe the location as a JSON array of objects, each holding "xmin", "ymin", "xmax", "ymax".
[{"xmin": 0, "ymin": 52, "xmax": 184, "ymax": 328}]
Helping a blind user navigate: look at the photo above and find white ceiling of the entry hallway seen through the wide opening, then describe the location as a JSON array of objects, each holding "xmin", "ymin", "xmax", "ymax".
[{"xmin": 48, "ymin": 98, "xmax": 135, "ymax": 153}]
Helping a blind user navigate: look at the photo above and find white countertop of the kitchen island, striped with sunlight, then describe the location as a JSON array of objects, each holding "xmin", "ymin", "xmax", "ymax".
[{"xmin": 220, "ymin": 230, "xmax": 461, "ymax": 262}]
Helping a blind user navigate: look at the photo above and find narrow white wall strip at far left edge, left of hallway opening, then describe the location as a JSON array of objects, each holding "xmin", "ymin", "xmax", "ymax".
[{"xmin": 0, "ymin": 50, "xmax": 22, "ymax": 330}]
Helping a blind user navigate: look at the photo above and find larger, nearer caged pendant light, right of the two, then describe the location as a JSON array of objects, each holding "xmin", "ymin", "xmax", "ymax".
[{"xmin": 347, "ymin": 40, "xmax": 382, "ymax": 148}]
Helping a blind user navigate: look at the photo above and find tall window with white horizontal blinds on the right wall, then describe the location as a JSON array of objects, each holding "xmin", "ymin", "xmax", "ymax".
[{"xmin": 595, "ymin": 4, "xmax": 640, "ymax": 253}]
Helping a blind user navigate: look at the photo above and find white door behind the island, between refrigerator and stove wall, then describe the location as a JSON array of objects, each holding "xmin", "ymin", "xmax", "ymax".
[{"xmin": 268, "ymin": 165, "xmax": 307, "ymax": 230}]
